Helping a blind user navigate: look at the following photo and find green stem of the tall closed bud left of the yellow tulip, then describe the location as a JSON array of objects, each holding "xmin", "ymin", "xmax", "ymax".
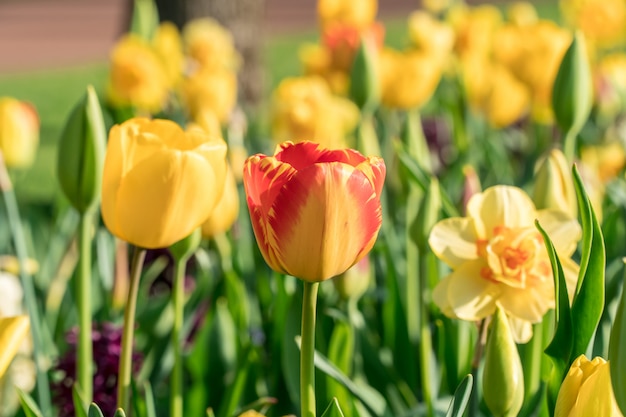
[{"xmin": 76, "ymin": 211, "xmax": 93, "ymax": 409}]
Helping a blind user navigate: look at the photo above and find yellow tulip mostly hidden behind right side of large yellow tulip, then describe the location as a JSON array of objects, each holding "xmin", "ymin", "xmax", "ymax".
[{"xmin": 202, "ymin": 166, "xmax": 239, "ymax": 238}]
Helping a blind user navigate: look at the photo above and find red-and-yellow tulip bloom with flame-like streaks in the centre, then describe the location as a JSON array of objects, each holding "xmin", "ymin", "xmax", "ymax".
[{"xmin": 243, "ymin": 142, "xmax": 386, "ymax": 282}]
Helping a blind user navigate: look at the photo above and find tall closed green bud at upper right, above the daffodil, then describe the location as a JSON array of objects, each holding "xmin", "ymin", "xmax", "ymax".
[{"xmin": 552, "ymin": 32, "xmax": 593, "ymax": 138}]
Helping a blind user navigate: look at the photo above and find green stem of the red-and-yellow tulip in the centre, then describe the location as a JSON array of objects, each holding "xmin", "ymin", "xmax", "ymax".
[{"xmin": 300, "ymin": 281, "xmax": 319, "ymax": 417}]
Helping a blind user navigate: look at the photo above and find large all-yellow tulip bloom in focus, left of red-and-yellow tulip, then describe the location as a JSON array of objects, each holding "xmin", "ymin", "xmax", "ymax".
[{"xmin": 102, "ymin": 118, "xmax": 226, "ymax": 249}]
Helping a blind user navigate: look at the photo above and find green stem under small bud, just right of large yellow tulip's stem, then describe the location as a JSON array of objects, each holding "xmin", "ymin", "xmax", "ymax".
[{"xmin": 170, "ymin": 256, "xmax": 189, "ymax": 417}]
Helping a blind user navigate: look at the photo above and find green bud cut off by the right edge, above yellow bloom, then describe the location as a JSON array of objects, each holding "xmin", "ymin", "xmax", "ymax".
[{"xmin": 609, "ymin": 258, "xmax": 626, "ymax": 415}]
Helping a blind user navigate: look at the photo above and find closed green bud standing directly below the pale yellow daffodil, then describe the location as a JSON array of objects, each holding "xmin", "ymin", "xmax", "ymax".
[{"xmin": 483, "ymin": 306, "xmax": 524, "ymax": 417}]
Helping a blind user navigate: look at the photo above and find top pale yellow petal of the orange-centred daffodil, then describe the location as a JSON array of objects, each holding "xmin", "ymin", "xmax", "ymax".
[{"xmin": 467, "ymin": 185, "xmax": 535, "ymax": 239}]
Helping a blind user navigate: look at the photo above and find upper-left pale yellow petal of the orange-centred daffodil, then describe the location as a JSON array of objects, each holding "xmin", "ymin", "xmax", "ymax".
[{"xmin": 428, "ymin": 217, "xmax": 478, "ymax": 268}]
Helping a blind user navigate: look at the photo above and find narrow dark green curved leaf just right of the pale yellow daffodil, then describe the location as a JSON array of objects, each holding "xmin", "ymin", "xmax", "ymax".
[{"xmin": 535, "ymin": 221, "xmax": 573, "ymax": 410}]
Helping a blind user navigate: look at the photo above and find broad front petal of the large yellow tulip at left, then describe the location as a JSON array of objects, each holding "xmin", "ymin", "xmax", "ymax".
[{"xmin": 112, "ymin": 150, "xmax": 224, "ymax": 249}]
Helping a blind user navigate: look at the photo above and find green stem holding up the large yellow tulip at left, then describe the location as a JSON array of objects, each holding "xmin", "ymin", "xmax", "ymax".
[{"xmin": 117, "ymin": 247, "xmax": 146, "ymax": 411}]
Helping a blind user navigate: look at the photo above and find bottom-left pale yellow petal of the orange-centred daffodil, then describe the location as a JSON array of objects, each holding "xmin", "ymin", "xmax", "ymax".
[{"xmin": 448, "ymin": 260, "xmax": 501, "ymax": 321}]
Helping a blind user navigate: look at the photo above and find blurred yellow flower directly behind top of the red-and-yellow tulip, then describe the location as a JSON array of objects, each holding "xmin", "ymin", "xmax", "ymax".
[{"xmin": 272, "ymin": 77, "xmax": 359, "ymax": 149}]
